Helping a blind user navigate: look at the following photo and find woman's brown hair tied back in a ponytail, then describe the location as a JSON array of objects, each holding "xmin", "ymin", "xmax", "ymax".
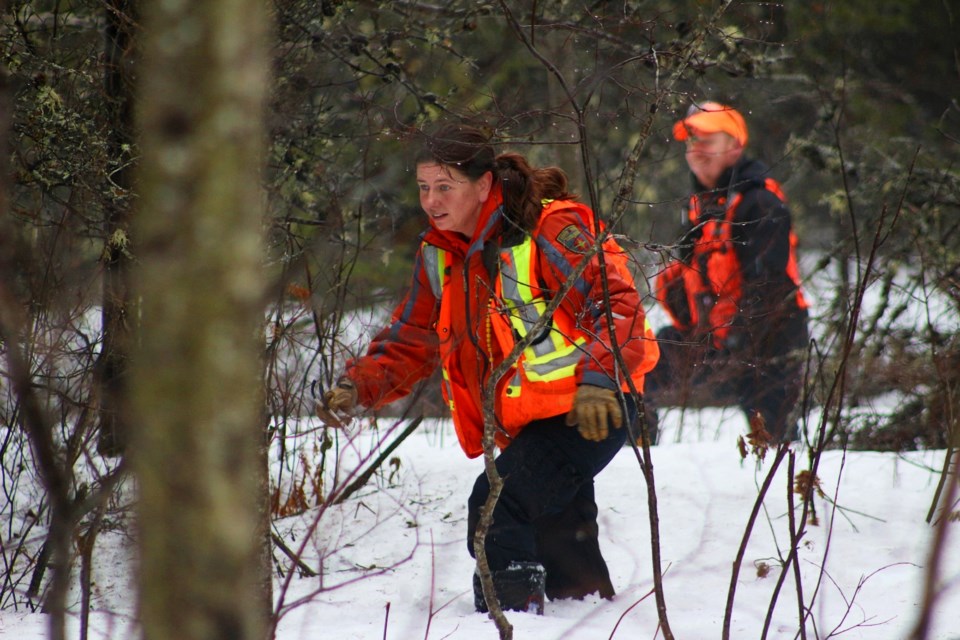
[{"xmin": 416, "ymin": 124, "xmax": 577, "ymax": 232}]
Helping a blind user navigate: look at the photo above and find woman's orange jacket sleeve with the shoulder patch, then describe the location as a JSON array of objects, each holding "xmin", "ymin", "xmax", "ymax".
[{"xmin": 537, "ymin": 210, "xmax": 657, "ymax": 389}]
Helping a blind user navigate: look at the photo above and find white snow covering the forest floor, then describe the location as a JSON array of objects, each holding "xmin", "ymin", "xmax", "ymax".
[{"xmin": 0, "ymin": 409, "xmax": 960, "ymax": 640}]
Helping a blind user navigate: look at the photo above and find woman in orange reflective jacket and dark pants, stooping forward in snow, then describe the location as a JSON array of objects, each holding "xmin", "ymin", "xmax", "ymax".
[{"xmin": 324, "ymin": 125, "xmax": 659, "ymax": 613}]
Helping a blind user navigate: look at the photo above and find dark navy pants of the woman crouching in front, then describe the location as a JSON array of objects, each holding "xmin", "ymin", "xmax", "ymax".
[{"xmin": 467, "ymin": 401, "xmax": 636, "ymax": 599}]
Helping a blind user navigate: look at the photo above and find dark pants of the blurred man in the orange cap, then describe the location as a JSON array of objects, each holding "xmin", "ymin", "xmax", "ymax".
[{"xmin": 644, "ymin": 310, "xmax": 809, "ymax": 441}]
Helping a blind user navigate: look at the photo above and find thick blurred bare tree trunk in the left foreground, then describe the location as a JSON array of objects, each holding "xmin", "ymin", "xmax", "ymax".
[{"xmin": 130, "ymin": 0, "xmax": 268, "ymax": 640}]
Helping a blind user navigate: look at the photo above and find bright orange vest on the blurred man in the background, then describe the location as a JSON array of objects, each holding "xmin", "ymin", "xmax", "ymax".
[{"xmin": 654, "ymin": 178, "xmax": 809, "ymax": 347}]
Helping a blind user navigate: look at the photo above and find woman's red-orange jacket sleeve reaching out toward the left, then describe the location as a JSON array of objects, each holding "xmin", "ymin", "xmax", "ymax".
[{"xmin": 345, "ymin": 251, "xmax": 438, "ymax": 408}]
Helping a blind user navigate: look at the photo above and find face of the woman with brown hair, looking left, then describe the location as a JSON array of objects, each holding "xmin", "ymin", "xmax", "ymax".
[{"xmin": 417, "ymin": 162, "xmax": 493, "ymax": 238}]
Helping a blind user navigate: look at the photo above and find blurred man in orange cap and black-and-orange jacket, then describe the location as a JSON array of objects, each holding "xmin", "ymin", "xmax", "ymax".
[{"xmin": 645, "ymin": 102, "xmax": 809, "ymax": 441}]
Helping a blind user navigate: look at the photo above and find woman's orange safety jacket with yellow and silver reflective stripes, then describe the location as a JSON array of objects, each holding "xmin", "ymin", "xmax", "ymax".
[{"xmin": 347, "ymin": 189, "xmax": 659, "ymax": 457}]
